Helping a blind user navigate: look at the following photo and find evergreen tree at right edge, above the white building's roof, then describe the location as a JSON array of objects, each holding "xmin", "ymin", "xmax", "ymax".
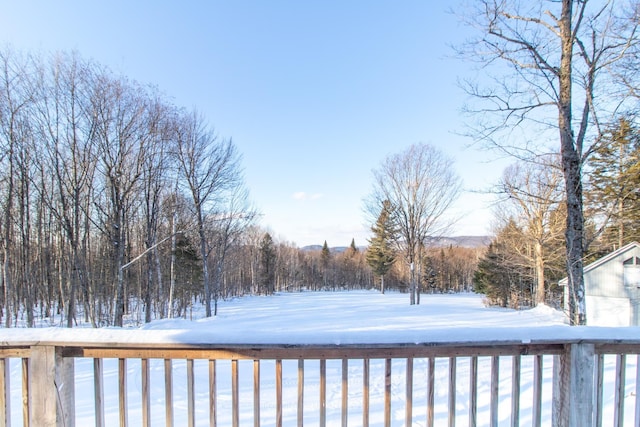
[{"xmin": 588, "ymin": 118, "xmax": 640, "ymax": 252}]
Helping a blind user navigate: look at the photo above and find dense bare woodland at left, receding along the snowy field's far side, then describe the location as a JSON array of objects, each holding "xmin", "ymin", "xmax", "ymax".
[{"xmin": 0, "ymin": 49, "xmax": 474, "ymax": 327}]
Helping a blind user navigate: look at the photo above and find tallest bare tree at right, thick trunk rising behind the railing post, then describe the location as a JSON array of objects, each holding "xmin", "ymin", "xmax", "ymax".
[{"xmin": 462, "ymin": 0, "xmax": 638, "ymax": 324}]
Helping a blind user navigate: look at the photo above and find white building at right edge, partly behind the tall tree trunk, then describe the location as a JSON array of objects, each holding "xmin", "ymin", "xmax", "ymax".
[{"xmin": 559, "ymin": 242, "xmax": 640, "ymax": 326}]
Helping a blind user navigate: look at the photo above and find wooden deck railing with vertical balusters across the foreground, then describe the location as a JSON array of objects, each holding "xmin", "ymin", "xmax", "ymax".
[{"xmin": 0, "ymin": 338, "xmax": 640, "ymax": 427}]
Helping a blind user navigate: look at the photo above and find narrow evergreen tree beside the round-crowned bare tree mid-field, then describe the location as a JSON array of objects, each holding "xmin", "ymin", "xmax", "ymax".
[{"xmin": 367, "ymin": 200, "xmax": 396, "ymax": 293}]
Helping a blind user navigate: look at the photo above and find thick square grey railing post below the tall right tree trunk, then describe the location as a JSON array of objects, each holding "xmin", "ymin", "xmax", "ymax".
[{"xmin": 552, "ymin": 343, "xmax": 594, "ymax": 427}]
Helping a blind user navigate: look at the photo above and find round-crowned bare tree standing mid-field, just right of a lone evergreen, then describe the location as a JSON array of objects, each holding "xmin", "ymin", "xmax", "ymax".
[{"xmin": 370, "ymin": 144, "xmax": 461, "ymax": 304}]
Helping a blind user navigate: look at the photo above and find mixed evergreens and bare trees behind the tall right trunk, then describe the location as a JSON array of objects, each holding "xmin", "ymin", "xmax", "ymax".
[{"xmin": 474, "ymin": 117, "xmax": 640, "ymax": 308}]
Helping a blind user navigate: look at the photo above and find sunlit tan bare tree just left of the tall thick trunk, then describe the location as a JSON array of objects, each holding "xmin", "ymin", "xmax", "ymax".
[{"xmin": 499, "ymin": 162, "xmax": 564, "ymax": 305}]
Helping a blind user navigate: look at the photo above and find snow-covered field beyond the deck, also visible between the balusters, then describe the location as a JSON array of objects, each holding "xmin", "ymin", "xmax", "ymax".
[{"xmin": 0, "ymin": 291, "xmax": 640, "ymax": 426}]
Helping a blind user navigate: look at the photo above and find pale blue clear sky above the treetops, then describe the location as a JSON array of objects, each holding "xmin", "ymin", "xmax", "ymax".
[{"xmin": 0, "ymin": 0, "xmax": 504, "ymax": 246}]
